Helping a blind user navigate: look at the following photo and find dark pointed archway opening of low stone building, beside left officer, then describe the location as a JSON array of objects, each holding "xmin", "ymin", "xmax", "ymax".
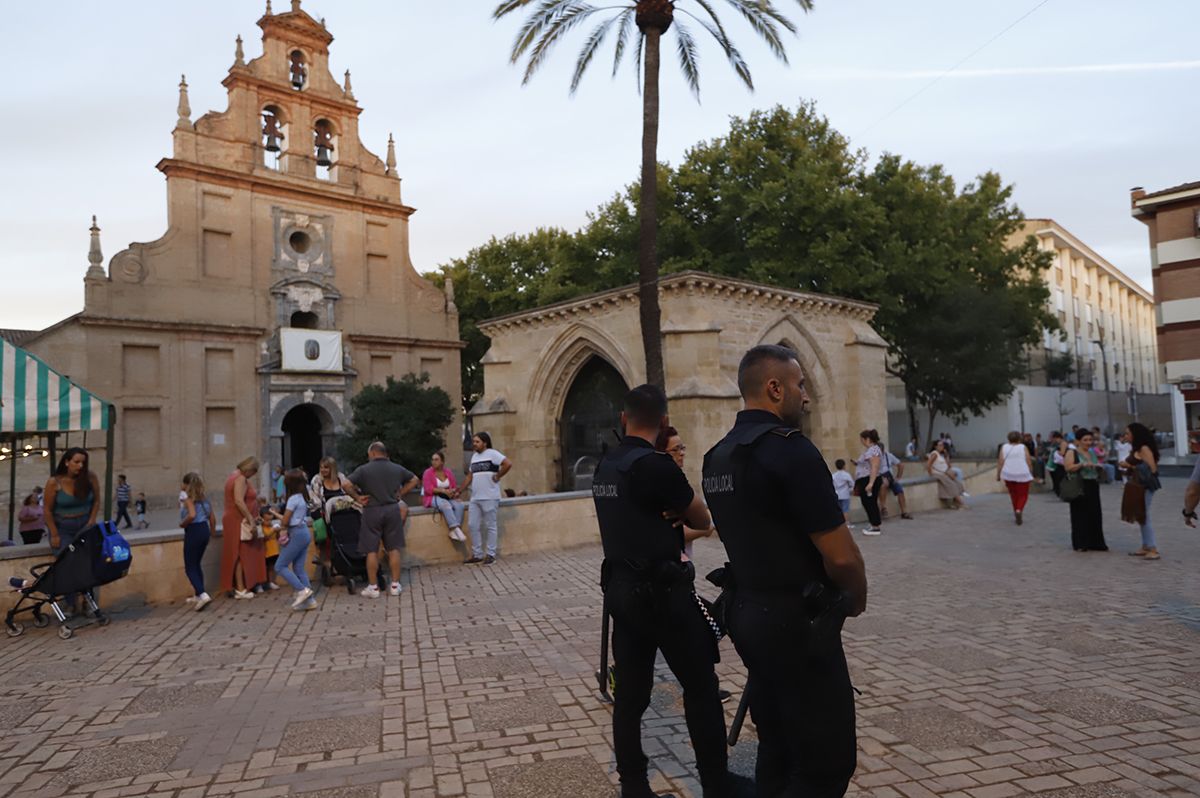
[{"xmin": 559, "ymin": 355, "xmax": 629, "ymax": 491}]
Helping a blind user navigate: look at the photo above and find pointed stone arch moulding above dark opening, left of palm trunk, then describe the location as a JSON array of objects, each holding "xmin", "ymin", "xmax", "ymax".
[{"xmin": 529, "ymin": 322, "xmax": 637, "ymax": 419}]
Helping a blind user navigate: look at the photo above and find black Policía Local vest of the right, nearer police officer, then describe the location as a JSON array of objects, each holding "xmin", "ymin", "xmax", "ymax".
[{"xmin": 703, "ymin": 422, "xmax": 829, "ymax": 592}]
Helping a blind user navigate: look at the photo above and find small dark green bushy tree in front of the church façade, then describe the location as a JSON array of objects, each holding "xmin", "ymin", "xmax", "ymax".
[{"xmin": 337, "ymin": 374, "xmax": 455, "ymax": 472}]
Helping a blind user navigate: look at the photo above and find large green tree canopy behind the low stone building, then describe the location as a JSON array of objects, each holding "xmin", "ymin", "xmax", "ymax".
[{"xmin": 442, "ymin": 104, "xmax": 1057, "ymax": 441}]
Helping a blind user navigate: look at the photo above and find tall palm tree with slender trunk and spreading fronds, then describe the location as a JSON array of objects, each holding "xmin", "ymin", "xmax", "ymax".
[{"xmin": 492, "ymin": 0, "xmax": 812, "ymax": 386}]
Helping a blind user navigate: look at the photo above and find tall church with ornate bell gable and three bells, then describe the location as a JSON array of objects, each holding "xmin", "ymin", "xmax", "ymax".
[{"xmin": 23, "ymin": 0, "xmax": 462, "ymax": 504}]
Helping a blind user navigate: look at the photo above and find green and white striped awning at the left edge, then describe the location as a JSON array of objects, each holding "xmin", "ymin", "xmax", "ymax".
[{"xmin": 0, "ymin": 340, "xmax": 108, "ymax": 432}]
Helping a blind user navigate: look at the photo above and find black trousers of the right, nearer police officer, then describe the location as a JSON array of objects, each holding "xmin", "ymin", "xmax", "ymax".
[{"xmin": 730, "ymin": 592, "xmax": 857, "ymax": 798}]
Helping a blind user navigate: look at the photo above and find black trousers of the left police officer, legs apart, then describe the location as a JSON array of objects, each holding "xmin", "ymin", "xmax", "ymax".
[{"xmin": 605, "ymin": 577, "xmax": 727, "ymax": 796}]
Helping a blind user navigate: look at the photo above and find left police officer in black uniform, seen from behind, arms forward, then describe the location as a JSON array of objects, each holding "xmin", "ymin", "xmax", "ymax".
[{"xmin": 592, "ymin": 385, "xmax": 731, "ymax": 798}]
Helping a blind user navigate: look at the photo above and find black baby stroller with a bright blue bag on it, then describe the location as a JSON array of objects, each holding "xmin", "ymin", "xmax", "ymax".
[{"xmin": 4, "ymin": 521, "xmax": 133, "ymax": 640}]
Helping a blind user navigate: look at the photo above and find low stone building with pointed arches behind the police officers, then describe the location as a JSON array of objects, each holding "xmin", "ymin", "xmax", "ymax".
[{"xmin": 470, "ymin": 271, "xmax": 887, "ymax": 493}]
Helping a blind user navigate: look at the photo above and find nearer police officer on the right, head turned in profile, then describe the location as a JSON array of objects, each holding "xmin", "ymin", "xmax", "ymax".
[{"xmin": 703, "ymin": 346, "xmax": 866, "ymax": 798}]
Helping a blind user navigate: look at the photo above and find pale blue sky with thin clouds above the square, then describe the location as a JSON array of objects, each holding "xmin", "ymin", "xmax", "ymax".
[{"xmin": 0, "ymin": 0, "xmax": 1200, "ymax": 329}]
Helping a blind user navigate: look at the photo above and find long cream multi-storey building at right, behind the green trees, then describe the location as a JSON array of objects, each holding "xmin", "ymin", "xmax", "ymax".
[{"xmin": 1014, "ymin": 218, "xmax": 1163, "ymax": 395}]
